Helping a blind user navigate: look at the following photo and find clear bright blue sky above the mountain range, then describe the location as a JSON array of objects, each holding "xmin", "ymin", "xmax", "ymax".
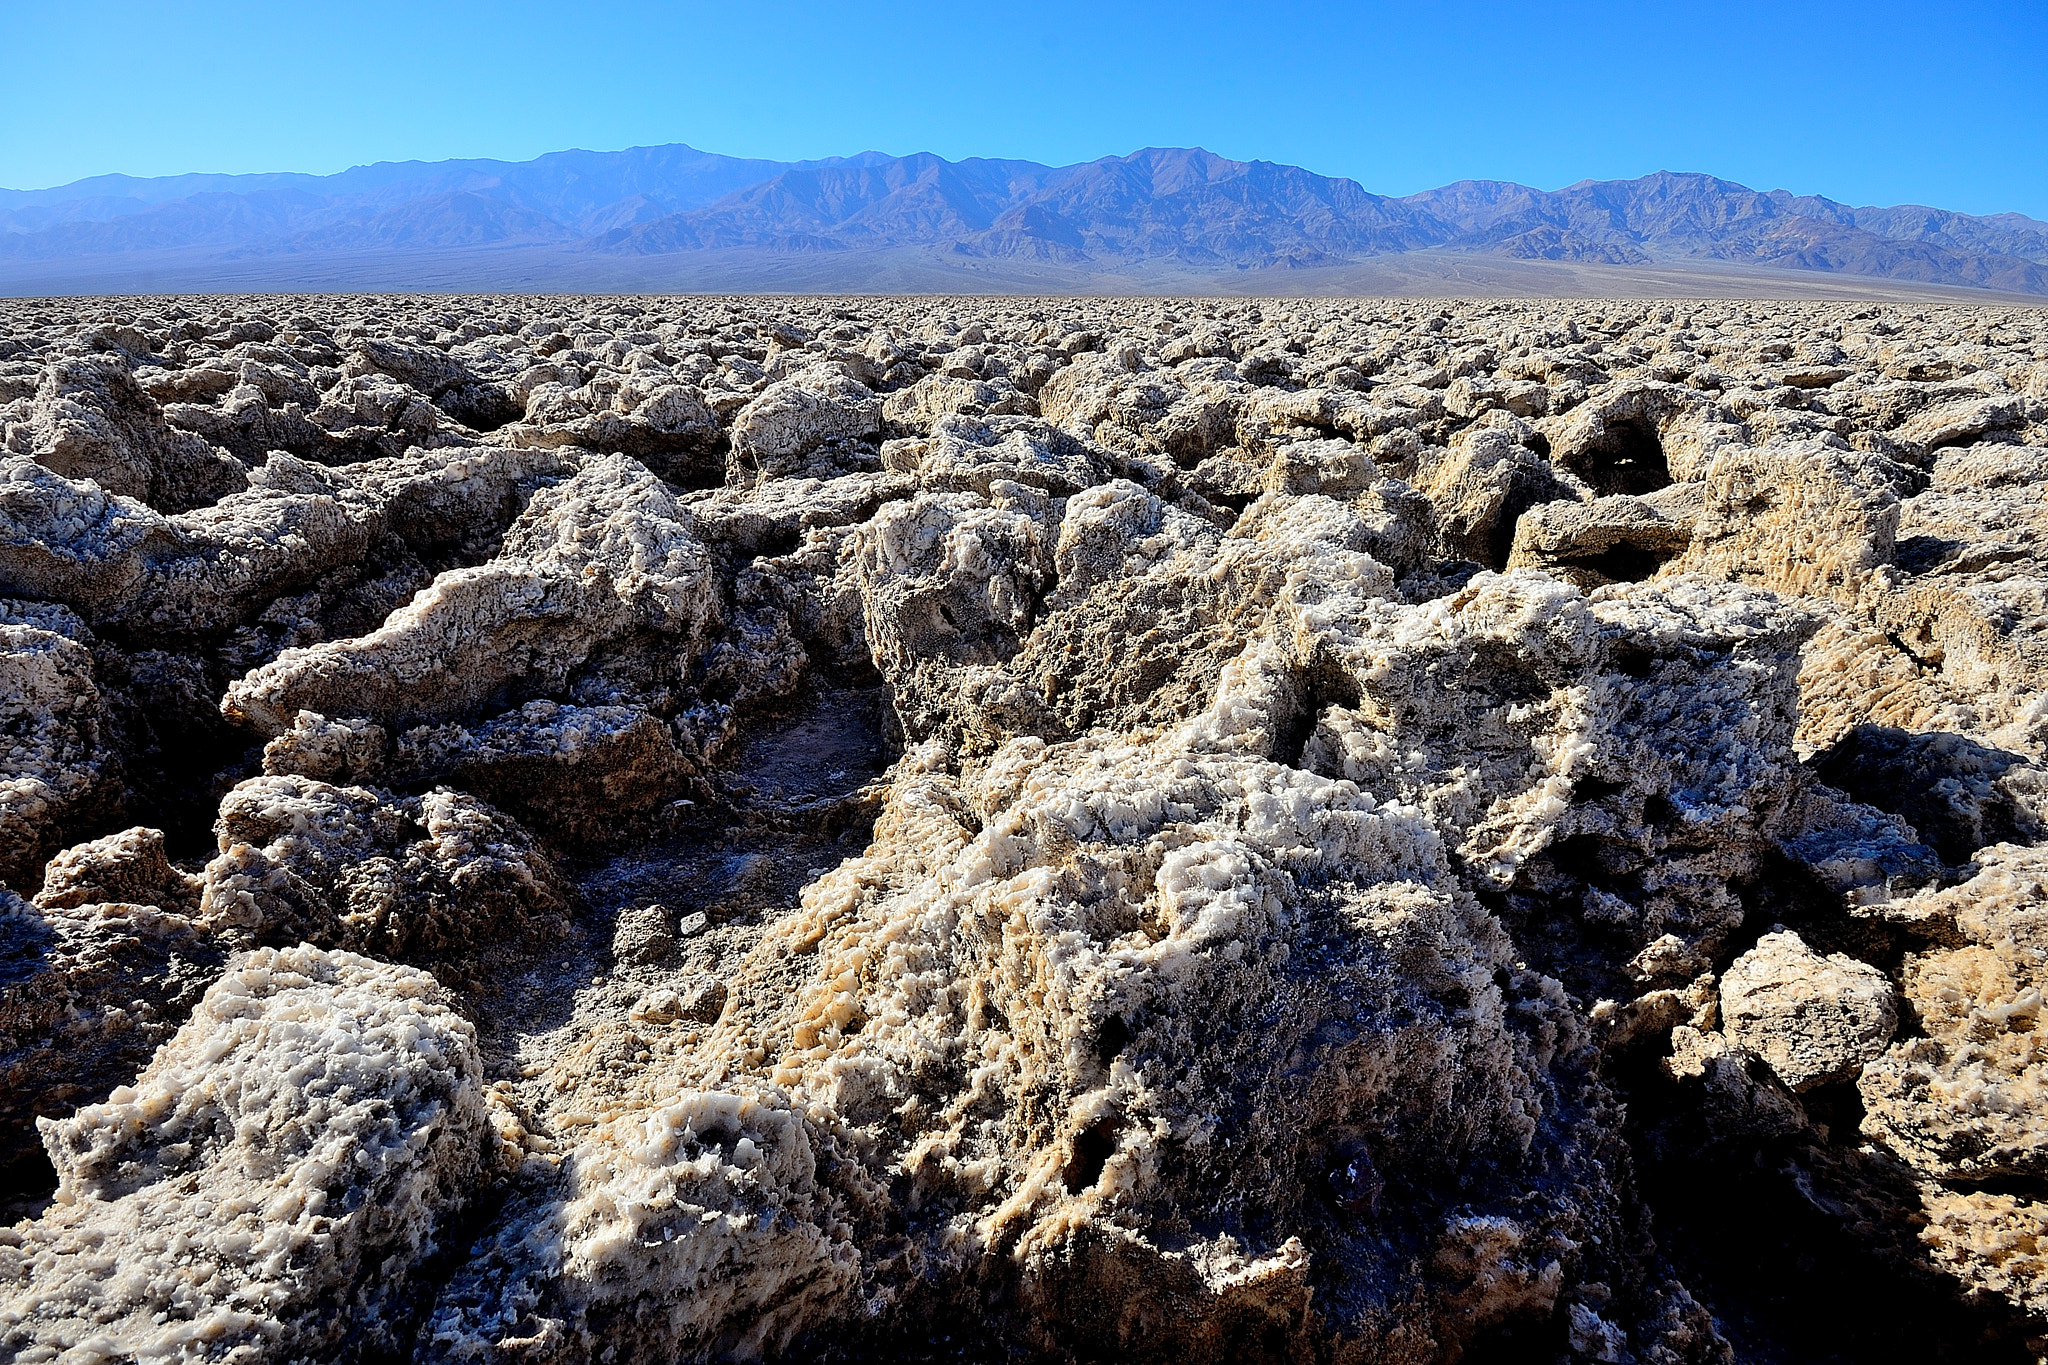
[{"xmin": 0, "ymin": 0, "xmax": 2048, "ymax": 219}]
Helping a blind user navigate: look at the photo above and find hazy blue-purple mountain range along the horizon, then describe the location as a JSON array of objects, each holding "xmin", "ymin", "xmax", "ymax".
[{"xmin": 0, "ymin": 143, "xmax": 2048, "ymax": 295}]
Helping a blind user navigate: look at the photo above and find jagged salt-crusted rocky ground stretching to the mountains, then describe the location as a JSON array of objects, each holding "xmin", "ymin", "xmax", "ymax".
[{"xmin": 0, "ymin": 297, "xmax": 2048, "ymax": 1365}]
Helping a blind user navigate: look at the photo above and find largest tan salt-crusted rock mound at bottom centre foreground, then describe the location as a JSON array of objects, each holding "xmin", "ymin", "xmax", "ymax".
[{"xmin": 448, "ymin": 663, "xmax": 1630, "ymax": 1355}]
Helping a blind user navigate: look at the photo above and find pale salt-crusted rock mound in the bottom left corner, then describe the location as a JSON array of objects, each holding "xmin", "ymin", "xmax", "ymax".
[{"xmin": 0, "ymin": 948, "xmax": 492, "ymax": 1361}]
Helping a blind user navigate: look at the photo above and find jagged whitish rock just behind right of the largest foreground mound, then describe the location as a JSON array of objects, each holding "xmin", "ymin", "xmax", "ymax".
[{"xmin": 1303, "ymin": 573, "xmax": 1810, "ymax": 970}]
